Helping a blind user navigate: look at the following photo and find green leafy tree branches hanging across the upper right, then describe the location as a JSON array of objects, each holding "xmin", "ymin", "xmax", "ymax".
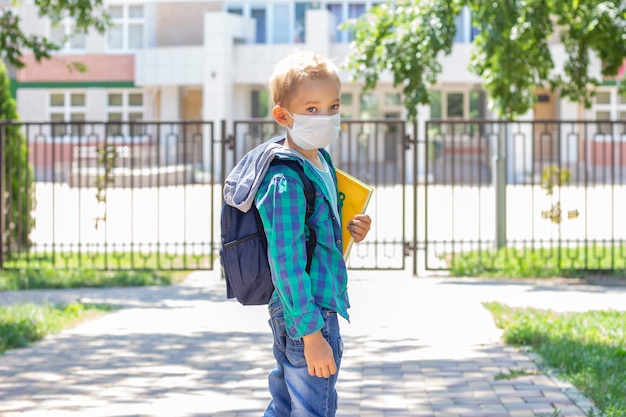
[{"xmin": 342, "ymin": 0, "xmax": 626, "ymax": 119}]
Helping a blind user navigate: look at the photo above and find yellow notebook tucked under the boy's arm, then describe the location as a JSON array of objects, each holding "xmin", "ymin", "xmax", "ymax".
[{"xmin": 335, "ymin": 168, "xmax": 374, "ymax": 259}]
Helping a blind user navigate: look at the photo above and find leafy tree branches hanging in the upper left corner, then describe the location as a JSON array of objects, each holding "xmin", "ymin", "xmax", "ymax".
[{"xmin": 0, "ymin": 0, "xmax": 110, "ymax": 71}]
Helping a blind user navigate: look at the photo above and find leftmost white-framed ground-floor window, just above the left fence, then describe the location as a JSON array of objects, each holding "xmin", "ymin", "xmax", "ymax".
[{"xmin": 48, "ymin": 91, "xmax": 86, "ymax": 137}]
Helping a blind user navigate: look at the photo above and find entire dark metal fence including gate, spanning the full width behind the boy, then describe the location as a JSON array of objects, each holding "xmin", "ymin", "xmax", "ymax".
[{"xmin": 0, "ymin": 120, "xmax": 626, "ymax": 273}]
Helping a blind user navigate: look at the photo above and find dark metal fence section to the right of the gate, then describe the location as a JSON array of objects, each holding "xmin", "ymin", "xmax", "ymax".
[{"xmin": 417, "ymin": 120, "xmax": 626, "ymax": 273}]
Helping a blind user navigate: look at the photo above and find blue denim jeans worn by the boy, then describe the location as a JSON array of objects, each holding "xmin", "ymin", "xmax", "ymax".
[{"xmin": 264, "ymin": 301, "xmax": 343, "ymax": 417}]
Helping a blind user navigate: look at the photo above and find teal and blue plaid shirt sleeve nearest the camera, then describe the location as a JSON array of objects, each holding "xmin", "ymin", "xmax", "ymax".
[{"xmin": 255, "ymin": 168, "xmax": 324, "ymax": 338}]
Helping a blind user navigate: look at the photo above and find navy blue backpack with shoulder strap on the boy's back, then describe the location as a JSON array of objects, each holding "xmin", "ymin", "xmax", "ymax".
[{"xmin": 220, "ymin": 158, "xmax": 317, "ymax": 305}]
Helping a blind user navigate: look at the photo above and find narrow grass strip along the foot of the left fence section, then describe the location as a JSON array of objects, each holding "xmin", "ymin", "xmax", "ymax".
[{"xmin": 0, "ymin": 267, "xmax": 173, "ymax": 291}]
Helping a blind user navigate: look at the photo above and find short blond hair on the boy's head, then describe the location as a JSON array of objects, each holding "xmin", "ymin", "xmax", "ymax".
[{"xmin": 270, "ymin": 51, "xmax": 340, "ymax": 106}]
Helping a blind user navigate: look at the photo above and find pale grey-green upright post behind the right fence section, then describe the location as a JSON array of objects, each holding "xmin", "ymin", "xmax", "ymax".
[{"xmin": 493, "ymin": 122, "xmax": 509, "ymax": 249}]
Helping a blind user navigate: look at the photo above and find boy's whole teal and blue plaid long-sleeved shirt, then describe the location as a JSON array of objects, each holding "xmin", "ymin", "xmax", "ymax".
[{"xmin": 255, "ymin": 153, "xmax": 350, "ymax": 339}]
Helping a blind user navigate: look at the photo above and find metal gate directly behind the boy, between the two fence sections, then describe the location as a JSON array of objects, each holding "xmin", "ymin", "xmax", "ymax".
[{"xmin": 221, "ymin": 120, "xmax": 417, "ymax": 269}]
